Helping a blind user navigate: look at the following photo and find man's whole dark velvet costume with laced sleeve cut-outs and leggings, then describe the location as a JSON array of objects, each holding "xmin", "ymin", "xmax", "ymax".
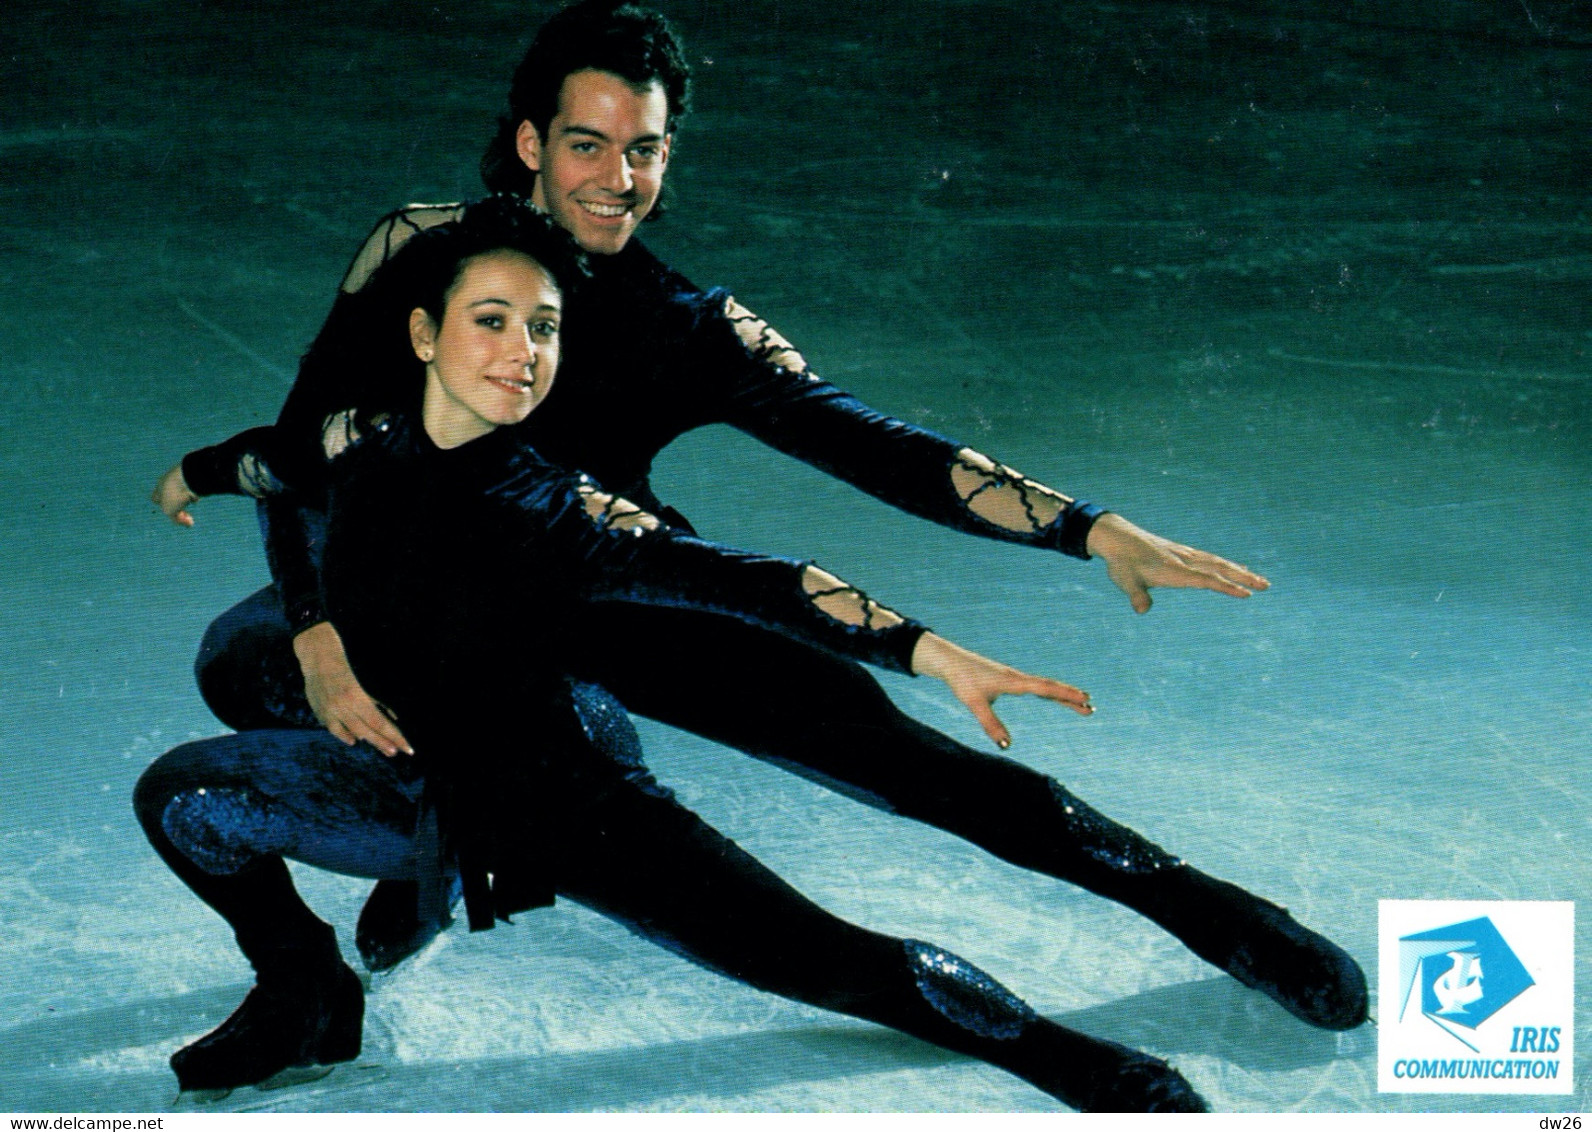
[{"xmin": 183, "ymin": 205, "xmax": 1364, "ymax": 1027}]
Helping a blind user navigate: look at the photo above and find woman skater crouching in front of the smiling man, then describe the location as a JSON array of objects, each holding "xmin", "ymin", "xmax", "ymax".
[{"xmin": 135, "ymin": 199, "xmax": 1204, "ymax": 1111}]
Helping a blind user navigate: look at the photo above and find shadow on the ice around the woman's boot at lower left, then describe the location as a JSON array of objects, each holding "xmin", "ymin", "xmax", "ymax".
[{"xmin": 0, "ymin": 984, "xmax": 955, "ymax": 1113}]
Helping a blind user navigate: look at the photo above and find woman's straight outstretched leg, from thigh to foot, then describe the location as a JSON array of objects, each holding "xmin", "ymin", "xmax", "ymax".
[{"xmin": 556, "ymin": 770, "xmax": 1204, "ymax": 1111}]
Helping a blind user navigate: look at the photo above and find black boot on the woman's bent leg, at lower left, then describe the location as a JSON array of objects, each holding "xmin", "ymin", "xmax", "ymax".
[{"xmin": 172, "ymin": 923, "xmax": 365, "ymax": 1091}]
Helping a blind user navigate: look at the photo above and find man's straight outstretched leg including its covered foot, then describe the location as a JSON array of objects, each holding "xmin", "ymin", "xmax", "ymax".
[{"xmin": 566, "ymin": 603, "xmax": 1368, "ymax": 1029}]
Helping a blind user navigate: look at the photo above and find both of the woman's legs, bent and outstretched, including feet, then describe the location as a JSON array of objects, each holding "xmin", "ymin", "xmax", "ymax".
[{"xmin": 135, "ymin": 697, "xmax": 1200, "ymax": 1110}]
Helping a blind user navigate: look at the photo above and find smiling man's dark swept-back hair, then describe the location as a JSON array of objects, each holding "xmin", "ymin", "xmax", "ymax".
[{"xmin": 481, "ymin": 0, "xmax": 691, "ymax": 211}]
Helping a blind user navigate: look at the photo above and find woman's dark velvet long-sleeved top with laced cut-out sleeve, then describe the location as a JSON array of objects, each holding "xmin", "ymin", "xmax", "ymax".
[{"xmin": 322, "ymin": 414, "xmax": 923, "ymax": 928}]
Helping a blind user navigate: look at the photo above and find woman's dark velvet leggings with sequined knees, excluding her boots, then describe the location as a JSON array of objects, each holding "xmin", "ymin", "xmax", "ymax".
[{"xmin": 135, "ymin": 706, "xmax": 1135, "ymax": 1107}]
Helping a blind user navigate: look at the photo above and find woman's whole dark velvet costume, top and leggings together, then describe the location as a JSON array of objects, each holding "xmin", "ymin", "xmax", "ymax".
[{"xmin": 135, "ymin": 402, "xmax": 1200, "ymax": 1111}]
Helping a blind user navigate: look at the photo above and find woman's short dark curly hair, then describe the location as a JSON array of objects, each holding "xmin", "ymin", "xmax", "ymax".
[{"xmin": 361, "ymin": 193, "xmax": 591, "ymax": 390}]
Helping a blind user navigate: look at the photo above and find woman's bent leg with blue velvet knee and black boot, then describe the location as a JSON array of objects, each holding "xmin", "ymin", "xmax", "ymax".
[{"xmin": 134, "ymin": 731, "xmax": 419, "ymax": 1089}]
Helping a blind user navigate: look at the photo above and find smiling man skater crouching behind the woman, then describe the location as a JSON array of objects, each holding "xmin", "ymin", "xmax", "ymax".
[{"xmin": 174, "ymin": 2, "xmax": 1366, "ymax": 1029}]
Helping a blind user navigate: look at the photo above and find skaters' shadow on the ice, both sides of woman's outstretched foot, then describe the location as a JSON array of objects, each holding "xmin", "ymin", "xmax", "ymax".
[{"xmin": 0, "ymin": 955, "xmax": 1374, "ymax": 1113}]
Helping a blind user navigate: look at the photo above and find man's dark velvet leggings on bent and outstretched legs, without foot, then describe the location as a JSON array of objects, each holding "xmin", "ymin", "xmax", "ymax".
[{"xmin": 196, "ymin": 589, "xmax": 1192, "ymax": 910}]
